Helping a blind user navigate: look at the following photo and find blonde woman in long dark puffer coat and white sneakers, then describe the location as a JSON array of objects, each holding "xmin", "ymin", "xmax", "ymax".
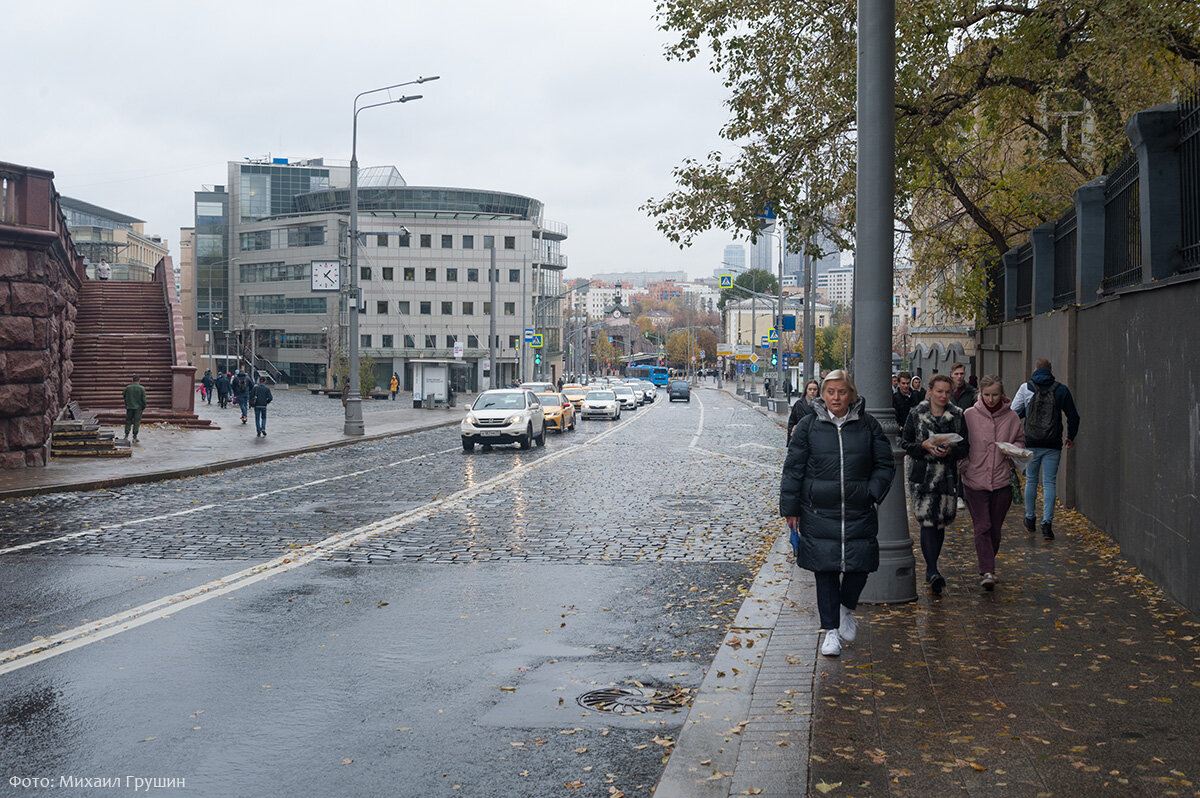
[{"xmin": 779, "ymin": 370, "xmax": 895, "ymax": 656}]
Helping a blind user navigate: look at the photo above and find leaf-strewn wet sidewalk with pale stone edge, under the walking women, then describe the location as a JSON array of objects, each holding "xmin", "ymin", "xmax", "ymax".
[{"xmin": 655, "ymin": 391, "xmax": 1200, "ymax": 798}]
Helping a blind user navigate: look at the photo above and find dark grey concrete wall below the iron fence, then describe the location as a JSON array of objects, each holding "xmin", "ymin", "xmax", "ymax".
[{"xmin": 978, "ymin": 275, "xmax": 1200, "ymax": 612}]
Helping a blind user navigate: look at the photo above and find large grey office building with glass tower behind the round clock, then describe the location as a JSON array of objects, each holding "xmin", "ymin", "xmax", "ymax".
[{"xmin": 196, "ymin": 161, "xmax": 566, "ymax": 390}]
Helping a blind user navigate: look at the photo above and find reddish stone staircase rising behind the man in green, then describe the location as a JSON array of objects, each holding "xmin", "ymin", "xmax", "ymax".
[{"xmin": 71, "ymin": 280, "xmax": 212, "ymax": 428}]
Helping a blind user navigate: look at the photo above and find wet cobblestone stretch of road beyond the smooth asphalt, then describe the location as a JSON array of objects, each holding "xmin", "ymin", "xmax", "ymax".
[{"xmin": 0, "ymin": 391, "xmax": 781, "ymax": 562}]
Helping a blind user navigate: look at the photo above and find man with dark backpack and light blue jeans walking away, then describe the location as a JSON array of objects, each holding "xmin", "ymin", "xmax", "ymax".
[{"xmin": 1012, "ymin": 358, "xmax": 1079, "ymax": 540}]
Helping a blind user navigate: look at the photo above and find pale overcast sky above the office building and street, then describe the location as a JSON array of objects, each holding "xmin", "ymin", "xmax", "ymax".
[{"xmin": 7, "ymin": 0, "xmax": 748, "ymax": 277}]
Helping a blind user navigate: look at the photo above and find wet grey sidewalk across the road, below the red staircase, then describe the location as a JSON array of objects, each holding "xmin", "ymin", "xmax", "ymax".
[{"xmin": 0, "ymin": 388, "xmax": 475, "ymax": 500}]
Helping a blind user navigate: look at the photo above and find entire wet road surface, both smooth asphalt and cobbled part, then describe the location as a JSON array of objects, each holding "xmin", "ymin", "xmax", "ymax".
[{"xmin": 0, "ymin": 390, "xmax": 782, "ymax": 796}]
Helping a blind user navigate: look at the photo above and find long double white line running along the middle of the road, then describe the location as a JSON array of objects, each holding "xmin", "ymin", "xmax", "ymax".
[{"xmin": 0, "ymin": 398, "xmax": 653, "ymax": 674}]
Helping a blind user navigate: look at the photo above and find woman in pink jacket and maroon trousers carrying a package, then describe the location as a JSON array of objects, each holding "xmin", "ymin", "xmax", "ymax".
[{"xmin": 961, "ymin": 376, "xmax": 1025, "ymax": 590}]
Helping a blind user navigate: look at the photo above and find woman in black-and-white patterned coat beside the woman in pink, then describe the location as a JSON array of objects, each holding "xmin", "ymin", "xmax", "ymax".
[{"xmin": 900, "ymin": 374, "xmax": 970, "ymax": 594}]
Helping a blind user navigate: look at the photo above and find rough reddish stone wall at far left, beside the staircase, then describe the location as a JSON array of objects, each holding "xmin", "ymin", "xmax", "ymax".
[{"xmin": 0, "ymin": 163, "xmax": 83, "ymax": 468}]
